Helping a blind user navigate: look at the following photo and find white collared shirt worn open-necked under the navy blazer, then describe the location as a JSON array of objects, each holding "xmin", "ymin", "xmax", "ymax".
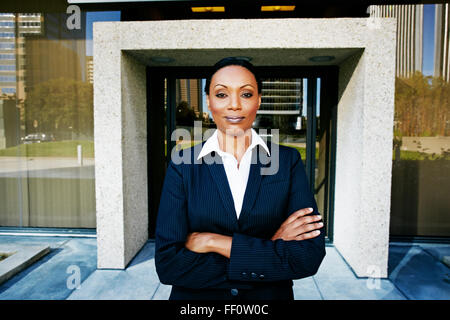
[{"xmin": 197, "ymin": 128, "xmax": 270, "ymax": 219}]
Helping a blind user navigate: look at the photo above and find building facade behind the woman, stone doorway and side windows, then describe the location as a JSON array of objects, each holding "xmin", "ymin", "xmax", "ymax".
[{"xmin": 0, "ymin": 1, "xmax": 450, "ymax": 276}]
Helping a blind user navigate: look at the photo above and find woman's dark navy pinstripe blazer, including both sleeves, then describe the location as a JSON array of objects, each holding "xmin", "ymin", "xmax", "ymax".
[{"xmin": 155, "ymin": 142, "xmax": 325, "ymax": 299}]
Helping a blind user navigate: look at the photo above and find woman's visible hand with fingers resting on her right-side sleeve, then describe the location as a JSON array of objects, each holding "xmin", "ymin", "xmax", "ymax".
[{"xmin": 271, "ymin": 208, "xmax": 323, "ymax": 241}]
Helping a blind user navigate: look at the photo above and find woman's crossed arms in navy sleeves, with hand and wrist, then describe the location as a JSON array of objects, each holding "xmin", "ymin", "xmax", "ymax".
[{"xmin": 155, "ymin": 152, "xmax": 325, "ymax": 288}]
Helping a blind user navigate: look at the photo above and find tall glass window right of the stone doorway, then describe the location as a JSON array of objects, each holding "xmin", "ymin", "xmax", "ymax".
[{"xmin": 374, "ymin": 3, "xmax": 450, "ymax": 237}]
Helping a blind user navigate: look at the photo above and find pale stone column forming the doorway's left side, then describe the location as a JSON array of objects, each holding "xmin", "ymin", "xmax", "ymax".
[{"xmin": 94, "ymin": 23, "xmax": 148, "ymax": 269}]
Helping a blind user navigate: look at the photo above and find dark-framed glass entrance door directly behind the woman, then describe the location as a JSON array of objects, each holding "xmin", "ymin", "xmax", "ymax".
[{"xmin": 149, "ymin": 73, "xmax": 332, "ymax": 239}]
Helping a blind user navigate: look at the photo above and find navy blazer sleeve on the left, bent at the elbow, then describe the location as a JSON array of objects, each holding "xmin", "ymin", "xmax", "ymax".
[{"xmin": 155, "ymin": 161, "xmax": 228, "ymax": 288}]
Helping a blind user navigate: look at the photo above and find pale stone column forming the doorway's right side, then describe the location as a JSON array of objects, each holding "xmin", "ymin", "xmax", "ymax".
[{"xmin": 334, "ymin": 18, "xmax": 396, "ymax": 277}]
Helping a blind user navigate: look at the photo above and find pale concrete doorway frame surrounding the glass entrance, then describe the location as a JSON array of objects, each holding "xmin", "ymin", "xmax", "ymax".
[{"xmin": 94, "ymin": 18, "xmax": 396, "ymax": 278}]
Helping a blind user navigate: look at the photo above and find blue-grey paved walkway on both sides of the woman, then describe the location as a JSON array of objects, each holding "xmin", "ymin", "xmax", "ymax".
[{"xmin": 0, "ymin": 235, "xmax": 450, "ymax": 300}]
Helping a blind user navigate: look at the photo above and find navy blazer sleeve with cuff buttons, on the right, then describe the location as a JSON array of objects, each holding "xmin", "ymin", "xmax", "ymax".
[{"xmin": 228, "ymin": 149, "xmax": 325, "ymax": 282}]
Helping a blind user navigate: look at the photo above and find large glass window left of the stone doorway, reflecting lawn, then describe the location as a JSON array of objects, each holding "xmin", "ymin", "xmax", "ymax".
[{"xmin": 0, "ymin": 9, "xmax": 120, "ymax": 228}]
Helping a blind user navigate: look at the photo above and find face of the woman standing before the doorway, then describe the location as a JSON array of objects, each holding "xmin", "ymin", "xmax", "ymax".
[{"xmin": 206, "ymin": 65, "xmax": 261, "ymax": 136}]
